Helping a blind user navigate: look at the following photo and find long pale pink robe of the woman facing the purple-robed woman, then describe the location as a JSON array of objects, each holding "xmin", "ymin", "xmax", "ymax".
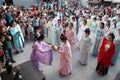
[{"xmin": 59, "ymin": 41, "xmax": 72, "ymax": 76}]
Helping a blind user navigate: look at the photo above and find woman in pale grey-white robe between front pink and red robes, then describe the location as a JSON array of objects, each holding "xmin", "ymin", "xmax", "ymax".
[{"xmin": 80, "ymin": 28, "xmax": 92, "ymax": 65}]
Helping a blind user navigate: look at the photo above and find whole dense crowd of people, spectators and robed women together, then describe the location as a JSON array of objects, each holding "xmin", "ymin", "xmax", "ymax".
[{"xmin": 0, "ymin": 2, "xmax": 120, "ymax": 80}]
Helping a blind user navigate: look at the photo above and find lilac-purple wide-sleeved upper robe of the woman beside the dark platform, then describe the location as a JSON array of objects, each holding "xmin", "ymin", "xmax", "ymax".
[{"xmin": 31, "ymin": 41, "xmax": 53, "ymax": 65}]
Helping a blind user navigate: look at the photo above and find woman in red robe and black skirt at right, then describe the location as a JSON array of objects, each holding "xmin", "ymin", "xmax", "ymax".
[{"xmin": 96, "ymin": 33, "xmax": 116, "ymax": 76}]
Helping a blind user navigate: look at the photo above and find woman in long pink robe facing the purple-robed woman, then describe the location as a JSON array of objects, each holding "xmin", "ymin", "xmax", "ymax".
[{"xmin": 54, "ymin": 34, "xmax": 72, "ymax": 76}]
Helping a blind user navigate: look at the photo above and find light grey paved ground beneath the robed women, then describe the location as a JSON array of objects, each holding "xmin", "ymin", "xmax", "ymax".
[{"xmin": 12, "ymin": 42, "xmax": 120, "ymax": 80}]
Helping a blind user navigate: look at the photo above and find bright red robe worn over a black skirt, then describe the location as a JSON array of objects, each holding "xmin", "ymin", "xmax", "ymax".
[{"xmin": 98, "ymin": 38, "xmax": 116, "ymax": 68}]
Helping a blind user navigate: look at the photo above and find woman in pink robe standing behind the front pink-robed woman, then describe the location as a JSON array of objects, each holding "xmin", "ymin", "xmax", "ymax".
[{"xmin": 66, "ymin": 23, "xmax": 75, "ymax": 49}]
